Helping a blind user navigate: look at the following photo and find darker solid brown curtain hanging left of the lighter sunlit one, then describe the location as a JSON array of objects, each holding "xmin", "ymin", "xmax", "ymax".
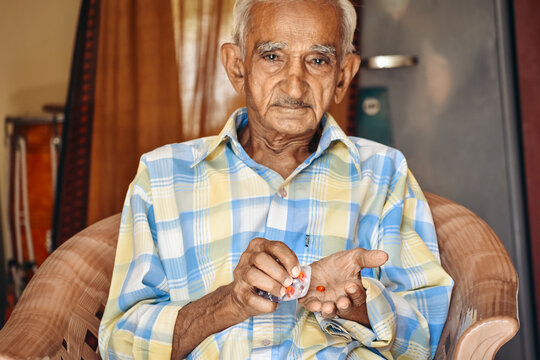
[{"xmin": 88, "ymin": 0, "xmax": 183, "ymax": 224}]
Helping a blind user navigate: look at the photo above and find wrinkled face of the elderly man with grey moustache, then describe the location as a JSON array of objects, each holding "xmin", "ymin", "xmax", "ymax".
[{"xmin": 243, "ymin": 0, "xmax": 341, "ymax": 137}]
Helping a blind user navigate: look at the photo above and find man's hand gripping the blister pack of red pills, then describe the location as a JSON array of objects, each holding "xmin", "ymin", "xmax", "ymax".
[{"xmin": 231, "ymin": 238, "xmax": 300, "ymax": 319}]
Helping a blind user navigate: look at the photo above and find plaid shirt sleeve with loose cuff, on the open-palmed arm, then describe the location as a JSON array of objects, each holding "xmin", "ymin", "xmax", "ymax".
[{"xmin": 317, "ymin": 159, "xmax": 453, "ymax": 359}]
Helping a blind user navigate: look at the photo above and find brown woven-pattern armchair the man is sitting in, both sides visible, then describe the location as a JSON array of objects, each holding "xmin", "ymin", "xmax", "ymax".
[{"xmin": 0, "ymin": 194, "xmax": 519, "ymax": 360}]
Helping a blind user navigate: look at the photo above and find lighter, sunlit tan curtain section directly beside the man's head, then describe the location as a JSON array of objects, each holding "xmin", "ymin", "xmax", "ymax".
[{"xmin": 172, "ymin": 0, "xmax": 244, "ymax": 139}]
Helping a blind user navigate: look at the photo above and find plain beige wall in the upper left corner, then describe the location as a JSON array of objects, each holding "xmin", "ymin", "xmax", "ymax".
[{"xmin": 0, "ymin": 0, "xmax": 80, "ymax": 264}]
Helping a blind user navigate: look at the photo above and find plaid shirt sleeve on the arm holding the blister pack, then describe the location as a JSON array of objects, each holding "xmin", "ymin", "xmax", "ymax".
[{"xmin": 99, "ymin": 158, "xmax": 186, "ymax": 359}]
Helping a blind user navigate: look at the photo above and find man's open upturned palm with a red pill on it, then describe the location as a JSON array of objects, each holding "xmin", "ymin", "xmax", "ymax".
[{"xmin": 298, "ymin": 248, "xmax": 388, "ymax": 326}]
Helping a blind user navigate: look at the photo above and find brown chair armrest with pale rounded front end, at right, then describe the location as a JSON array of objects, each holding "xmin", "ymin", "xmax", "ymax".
[{"xmin": 426, "ymin": 193, "xmax": 519, "ymax": 360}]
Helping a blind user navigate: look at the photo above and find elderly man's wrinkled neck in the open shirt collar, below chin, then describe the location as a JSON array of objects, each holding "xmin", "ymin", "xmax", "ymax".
[{"xmin": 238, "ymin": 123, "xmax": 321, "ymax": 179}]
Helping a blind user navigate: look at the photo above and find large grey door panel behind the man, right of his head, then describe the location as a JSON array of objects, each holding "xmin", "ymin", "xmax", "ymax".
[{"xmin": 360, "ymin": 0, "xmax": 536, "ymax": 359}]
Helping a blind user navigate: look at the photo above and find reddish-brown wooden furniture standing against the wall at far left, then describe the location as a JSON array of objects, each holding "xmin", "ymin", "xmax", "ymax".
[{"xmin": 6, "ymin": 112, "xmax": 64, "ymax": 266}]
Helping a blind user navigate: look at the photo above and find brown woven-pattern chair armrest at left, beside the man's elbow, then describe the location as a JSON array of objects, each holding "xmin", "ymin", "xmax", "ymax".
[{"xmin": 0, "ymin": 214, "xmax": 120, "ymax": 359}]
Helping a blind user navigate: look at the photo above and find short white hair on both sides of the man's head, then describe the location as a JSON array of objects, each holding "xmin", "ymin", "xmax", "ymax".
[{"xmin": 233, "ymin": 0, "xmax": 356, "ymax": 57}]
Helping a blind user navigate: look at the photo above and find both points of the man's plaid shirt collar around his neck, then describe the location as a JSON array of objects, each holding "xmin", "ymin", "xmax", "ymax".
[{"xmin": 191, "ymin": 108, "xmax": 360, "ymax": 171}]
